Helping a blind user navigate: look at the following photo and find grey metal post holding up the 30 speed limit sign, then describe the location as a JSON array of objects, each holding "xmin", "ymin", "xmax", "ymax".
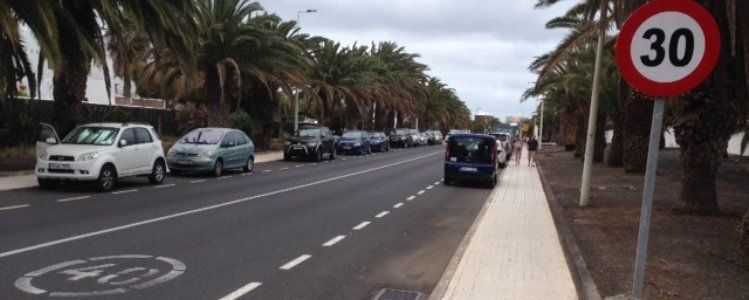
[{"xmin": 632, "ymin": 99, "xmax": 666, "ymax": 300}]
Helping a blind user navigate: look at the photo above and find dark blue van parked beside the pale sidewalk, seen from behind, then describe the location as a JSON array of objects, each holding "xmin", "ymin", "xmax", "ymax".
[{"xmin": 445, "ymin": 134, "xmax": 498, "ymax": 187}]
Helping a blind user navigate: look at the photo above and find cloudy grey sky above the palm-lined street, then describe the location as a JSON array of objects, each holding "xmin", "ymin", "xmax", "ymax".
[{"xmin": 260, "ymin": 0, "xmax": 575, "ymax": 120}]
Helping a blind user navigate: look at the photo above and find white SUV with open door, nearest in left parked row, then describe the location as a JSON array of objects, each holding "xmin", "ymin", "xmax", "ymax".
[{"xmin": 36, "ymin": 123, "xmax": 166, "ymax": 191}]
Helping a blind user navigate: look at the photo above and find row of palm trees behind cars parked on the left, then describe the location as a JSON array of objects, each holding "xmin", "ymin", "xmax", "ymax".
[{"xmin": 0, "ymin": 0, "xmax": 470, "ymax": 147}]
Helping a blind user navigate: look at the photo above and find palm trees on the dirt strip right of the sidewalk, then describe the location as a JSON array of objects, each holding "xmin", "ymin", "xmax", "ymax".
[{"xmin": 525, "ymin": 0, "xmax": 749, "ymax": 276}]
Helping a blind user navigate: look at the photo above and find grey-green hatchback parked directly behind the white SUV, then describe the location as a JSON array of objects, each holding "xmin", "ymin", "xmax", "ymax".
[{"xmin": 166, "ymin": 128, "xmax": 255, "ymax": 177}]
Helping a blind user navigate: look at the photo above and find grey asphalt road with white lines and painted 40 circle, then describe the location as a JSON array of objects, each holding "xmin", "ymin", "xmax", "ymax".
[{"xmin": 0, "ymin": 146, "xmax": 491, "ymax": 299}]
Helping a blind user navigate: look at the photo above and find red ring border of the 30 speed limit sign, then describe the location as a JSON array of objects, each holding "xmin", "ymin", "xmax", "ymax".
[{"xmin": 616, "ymin": 0, "xmax": 720, "ymax": 97}]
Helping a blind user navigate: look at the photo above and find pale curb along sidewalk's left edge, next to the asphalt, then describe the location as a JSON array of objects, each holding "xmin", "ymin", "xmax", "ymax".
[{"xmin": 428, "ymin": 171, "xmax": 504, "ymax": 300}]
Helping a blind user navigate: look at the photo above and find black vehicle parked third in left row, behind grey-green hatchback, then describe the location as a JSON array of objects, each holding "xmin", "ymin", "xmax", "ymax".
[{"xmin": 283, "ymin": 127, "xmax": 338, "ymax": 161}]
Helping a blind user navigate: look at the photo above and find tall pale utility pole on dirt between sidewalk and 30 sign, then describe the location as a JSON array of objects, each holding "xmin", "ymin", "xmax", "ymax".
[{"xmin": 580, "ymin": 0, "xmax": 609, "ymax": 207}]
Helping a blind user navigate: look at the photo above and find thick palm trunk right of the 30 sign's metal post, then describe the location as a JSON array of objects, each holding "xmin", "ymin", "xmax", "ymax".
[{"xmin": 674, "ymin": 1, "xmax": 746, "ymax": 214}]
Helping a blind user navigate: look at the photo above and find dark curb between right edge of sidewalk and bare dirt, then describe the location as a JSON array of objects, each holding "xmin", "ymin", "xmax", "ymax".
[{"xmin": 536, "ymin": 160, "xmax": 601, "ymax": 300}]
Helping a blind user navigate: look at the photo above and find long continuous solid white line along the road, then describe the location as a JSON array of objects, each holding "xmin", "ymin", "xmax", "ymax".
[{"xmin": 0, "ymin": 152, "xmax": 442, "ymax": 258}]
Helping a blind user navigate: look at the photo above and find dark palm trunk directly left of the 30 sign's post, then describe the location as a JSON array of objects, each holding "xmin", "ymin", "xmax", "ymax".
[{"xmin": 623, "ymin": 91, "xmax": 653, "ymax": 174}]
